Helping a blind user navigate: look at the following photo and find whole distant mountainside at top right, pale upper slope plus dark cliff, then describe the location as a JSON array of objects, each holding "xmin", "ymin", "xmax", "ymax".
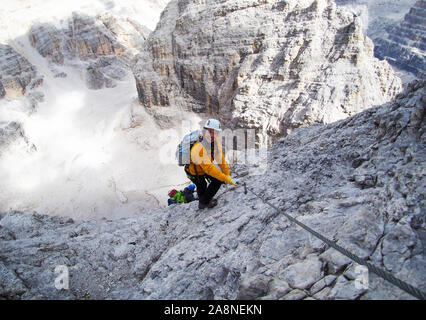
[{"xmin": 336, "ymin": 0, "xmax": 426, "ymax": 79}]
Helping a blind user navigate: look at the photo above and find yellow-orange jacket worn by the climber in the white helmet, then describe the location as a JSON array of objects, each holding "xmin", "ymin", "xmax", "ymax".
[{"xmin": 187, "ymin": 138, "xmax": 231, "ymax": 183}]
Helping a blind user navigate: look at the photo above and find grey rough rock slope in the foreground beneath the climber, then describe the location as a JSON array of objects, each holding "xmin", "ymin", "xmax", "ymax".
[{"xmin": 0, "ymin": 81, "xmax": 426, "ymax": 299}]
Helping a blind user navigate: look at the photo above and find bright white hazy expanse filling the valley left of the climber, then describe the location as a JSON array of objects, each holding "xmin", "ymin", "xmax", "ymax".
[{"xmin": 0, "ymin": 1, "xmax": 206, "ymax": 219}]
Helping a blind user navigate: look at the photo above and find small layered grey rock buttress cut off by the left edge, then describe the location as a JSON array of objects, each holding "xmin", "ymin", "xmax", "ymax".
[{"xmin": 0, "ymin": 44, "xmax": 43, "ymax": 99}]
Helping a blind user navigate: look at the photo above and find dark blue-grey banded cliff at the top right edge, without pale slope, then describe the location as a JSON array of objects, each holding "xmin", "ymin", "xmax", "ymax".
[{"xmin": 374, "ymin": 0, "xmax": 426, "ymax": 79}]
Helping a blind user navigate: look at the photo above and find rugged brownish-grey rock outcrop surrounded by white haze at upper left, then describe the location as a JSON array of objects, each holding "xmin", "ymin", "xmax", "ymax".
[{"xmin": 29, "ymin": 12, "xmax": 150, "ymax": 89}]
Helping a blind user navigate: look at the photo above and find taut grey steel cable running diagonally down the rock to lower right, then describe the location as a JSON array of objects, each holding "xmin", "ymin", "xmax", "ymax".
[{"xmin": 243, "ymin": 183, "xmax": 426, "ymax": 300}]
